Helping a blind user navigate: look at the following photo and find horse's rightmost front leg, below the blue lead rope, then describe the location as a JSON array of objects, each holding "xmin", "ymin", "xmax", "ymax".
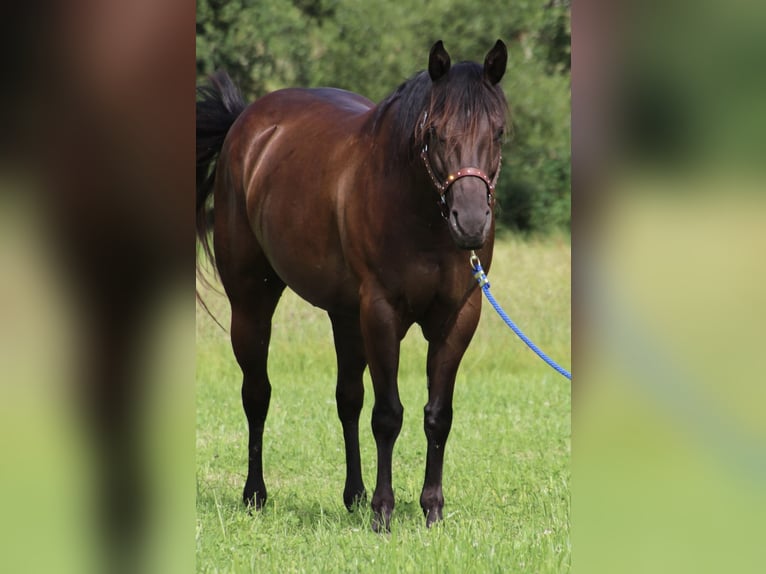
[{"xmin": 420, "ymin": 289, "xmax": 481, "ymax": 528}]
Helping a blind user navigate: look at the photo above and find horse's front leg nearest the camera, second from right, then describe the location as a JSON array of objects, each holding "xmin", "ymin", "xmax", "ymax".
[{"xmin": 361, "ymin": 292, "xmax": 404, "ymax": 532}]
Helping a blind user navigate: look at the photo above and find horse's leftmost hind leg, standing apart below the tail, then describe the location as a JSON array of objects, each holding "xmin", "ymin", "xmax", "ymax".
[{"xmin": 230, "ymin": 267, "xmax": 285, "ymax": 509}]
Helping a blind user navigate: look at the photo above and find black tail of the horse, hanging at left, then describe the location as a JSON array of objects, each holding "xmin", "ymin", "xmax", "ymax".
[{"xmin": 196, "ymin": 71, "xmax": 247, "ymax": 265}]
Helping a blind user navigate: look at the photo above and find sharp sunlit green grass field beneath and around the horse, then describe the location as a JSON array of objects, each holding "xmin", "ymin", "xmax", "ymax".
[{"xmin": 196, "ymin": 237, "xmax": 571, "ymax": 573}]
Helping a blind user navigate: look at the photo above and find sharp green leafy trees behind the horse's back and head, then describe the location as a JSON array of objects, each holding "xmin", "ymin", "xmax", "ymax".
[{"xmin": 197, "ymin": 0, "xmax": 571, "ymax": 233}]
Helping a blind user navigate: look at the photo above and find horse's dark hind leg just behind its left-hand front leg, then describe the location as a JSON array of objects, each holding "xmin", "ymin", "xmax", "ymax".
[{"xmin": 330, "ymin": 313, "xmax": 367, "ymax": 512}]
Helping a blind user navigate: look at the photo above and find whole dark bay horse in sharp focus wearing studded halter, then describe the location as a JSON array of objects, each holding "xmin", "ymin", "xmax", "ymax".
[{"xmin": 197, "ymin": 40, "xmax": 508, "ymax": 530}]
